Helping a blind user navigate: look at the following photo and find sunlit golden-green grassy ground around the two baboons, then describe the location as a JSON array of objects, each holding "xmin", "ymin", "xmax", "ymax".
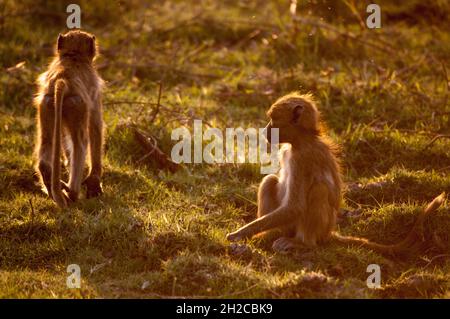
[{"xmin": 0, "ymin": 0, "xmax": 450, "ymax": 298}]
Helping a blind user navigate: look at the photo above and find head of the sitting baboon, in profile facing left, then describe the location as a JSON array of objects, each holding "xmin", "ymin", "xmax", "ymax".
[{"xmin": 266, "ymin": 92, "xmax": 320, "ymax": 143}]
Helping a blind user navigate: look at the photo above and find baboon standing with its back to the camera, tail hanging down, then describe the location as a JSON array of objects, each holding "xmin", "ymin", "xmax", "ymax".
[{"xmin": 34, "ymin": 30, "xmax": 103, "ymax": 208}]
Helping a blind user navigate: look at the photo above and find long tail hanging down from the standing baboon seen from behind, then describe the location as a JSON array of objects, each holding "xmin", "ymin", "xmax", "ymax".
[{"xmin": 52, "ymin": 79, "xmax": 67, "ymax": 208}]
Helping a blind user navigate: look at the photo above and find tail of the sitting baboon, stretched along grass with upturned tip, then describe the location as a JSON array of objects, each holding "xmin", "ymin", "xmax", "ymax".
[{"xmin": 332, "ymin": 193, "xmax": 445, "ymax": 255}]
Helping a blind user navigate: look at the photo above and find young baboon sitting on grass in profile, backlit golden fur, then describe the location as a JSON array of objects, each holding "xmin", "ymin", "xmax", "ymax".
[{"xmin": 227, "ymin": 93, "xmax": 445, "ymax": 255}]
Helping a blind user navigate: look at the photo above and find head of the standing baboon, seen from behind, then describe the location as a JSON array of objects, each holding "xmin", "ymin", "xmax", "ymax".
[{"xmin": 56, "ymin": 30, "xmax": 97, "ymax": 61}]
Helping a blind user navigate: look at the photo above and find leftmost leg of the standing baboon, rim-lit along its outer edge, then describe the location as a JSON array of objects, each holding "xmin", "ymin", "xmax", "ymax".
[{"xmin": 36, "ymin": 98, "xmax": 55, "ymax": 197}]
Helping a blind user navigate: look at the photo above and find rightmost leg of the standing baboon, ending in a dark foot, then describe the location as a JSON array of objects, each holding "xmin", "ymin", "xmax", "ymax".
[{"xmin": 85, "ymin": 100, "xmax": 103, "ymax": 198}]
